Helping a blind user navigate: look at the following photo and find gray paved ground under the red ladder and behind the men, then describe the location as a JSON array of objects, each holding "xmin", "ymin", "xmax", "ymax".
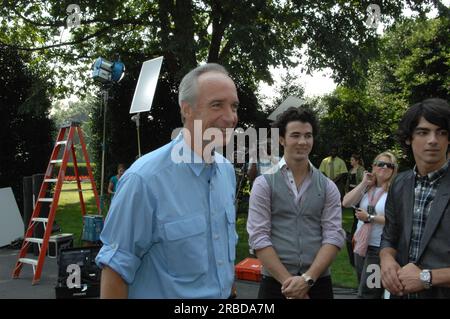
[{"xmin": 0, "ymin": 248, "xmax": 356, "ymax": 299}]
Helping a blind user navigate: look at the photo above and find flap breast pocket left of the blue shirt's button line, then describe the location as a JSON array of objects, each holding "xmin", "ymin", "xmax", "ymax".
[{"xmin": 164, "ymin": 216, "xmax": 208, "ymax": 276}]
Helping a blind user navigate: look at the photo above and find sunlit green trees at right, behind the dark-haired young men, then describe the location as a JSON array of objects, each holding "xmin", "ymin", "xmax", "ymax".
[{"xmin": 320, "ymin": 16, "xmax": 450, "ymax": 167}]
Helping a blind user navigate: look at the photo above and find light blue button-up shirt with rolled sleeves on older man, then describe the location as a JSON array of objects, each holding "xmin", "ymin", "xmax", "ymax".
[{"xmin": 96, "ymin": 134, "xmax": 237, "ymax": 298}]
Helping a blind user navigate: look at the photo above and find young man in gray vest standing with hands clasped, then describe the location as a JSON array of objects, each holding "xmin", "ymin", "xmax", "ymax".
[{"xmin": 247, "ymin": 108, "xmax": 345, "ymax": 299}]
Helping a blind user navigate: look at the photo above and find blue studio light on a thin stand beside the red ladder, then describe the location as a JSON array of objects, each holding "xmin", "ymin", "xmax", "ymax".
[{"xmin": 92, "ymin": 56, "xmax": 125, "ymax": 213}]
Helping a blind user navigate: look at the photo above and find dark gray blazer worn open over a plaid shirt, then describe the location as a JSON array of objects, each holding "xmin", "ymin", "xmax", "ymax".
[{"xmin": 381, "ymin": 169, "xmax": 450, "ymax": 298}]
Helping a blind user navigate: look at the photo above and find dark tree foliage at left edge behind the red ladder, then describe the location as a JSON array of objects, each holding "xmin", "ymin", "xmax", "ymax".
[{"xmin": 0, "ymin": 45, "xmax": 54, "ymax": 208}]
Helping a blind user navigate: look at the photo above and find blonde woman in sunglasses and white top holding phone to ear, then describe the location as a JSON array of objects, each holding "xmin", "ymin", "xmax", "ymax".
[{"xmin": 342, "ymin": 152, "xmax": 397, "ymax": 299}]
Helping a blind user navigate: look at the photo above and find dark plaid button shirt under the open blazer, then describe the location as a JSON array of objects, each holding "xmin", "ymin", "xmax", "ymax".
[{"xmin": 409, "ymin": 161, "xmax": 449, "ymax": 264}]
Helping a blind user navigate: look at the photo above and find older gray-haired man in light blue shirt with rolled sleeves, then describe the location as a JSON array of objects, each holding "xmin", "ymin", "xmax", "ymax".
[{"xmin": 96, "ymin": 64, "xmax": 239, "ymax": 298}]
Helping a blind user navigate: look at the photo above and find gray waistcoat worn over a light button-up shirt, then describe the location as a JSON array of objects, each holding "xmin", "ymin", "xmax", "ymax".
[{"xmin": 262, "ymin": 165, "xmax": 330, "ymax": 277}]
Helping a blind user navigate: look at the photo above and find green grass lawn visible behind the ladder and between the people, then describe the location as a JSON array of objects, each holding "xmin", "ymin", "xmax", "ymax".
[{"xmin": 56, "ymin": 182, "xmax": 357, "ymax": 288}]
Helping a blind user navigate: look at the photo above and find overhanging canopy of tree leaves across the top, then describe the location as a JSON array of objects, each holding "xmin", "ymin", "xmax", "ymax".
[{"xmin": 0, "ymin": 0, "xmax": 440, "ymax": 89}]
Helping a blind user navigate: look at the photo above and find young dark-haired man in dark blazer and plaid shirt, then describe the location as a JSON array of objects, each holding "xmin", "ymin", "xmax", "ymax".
[{"xmin": 380, "ymin": 99, "xmax": 450, "ymax": 299}]
